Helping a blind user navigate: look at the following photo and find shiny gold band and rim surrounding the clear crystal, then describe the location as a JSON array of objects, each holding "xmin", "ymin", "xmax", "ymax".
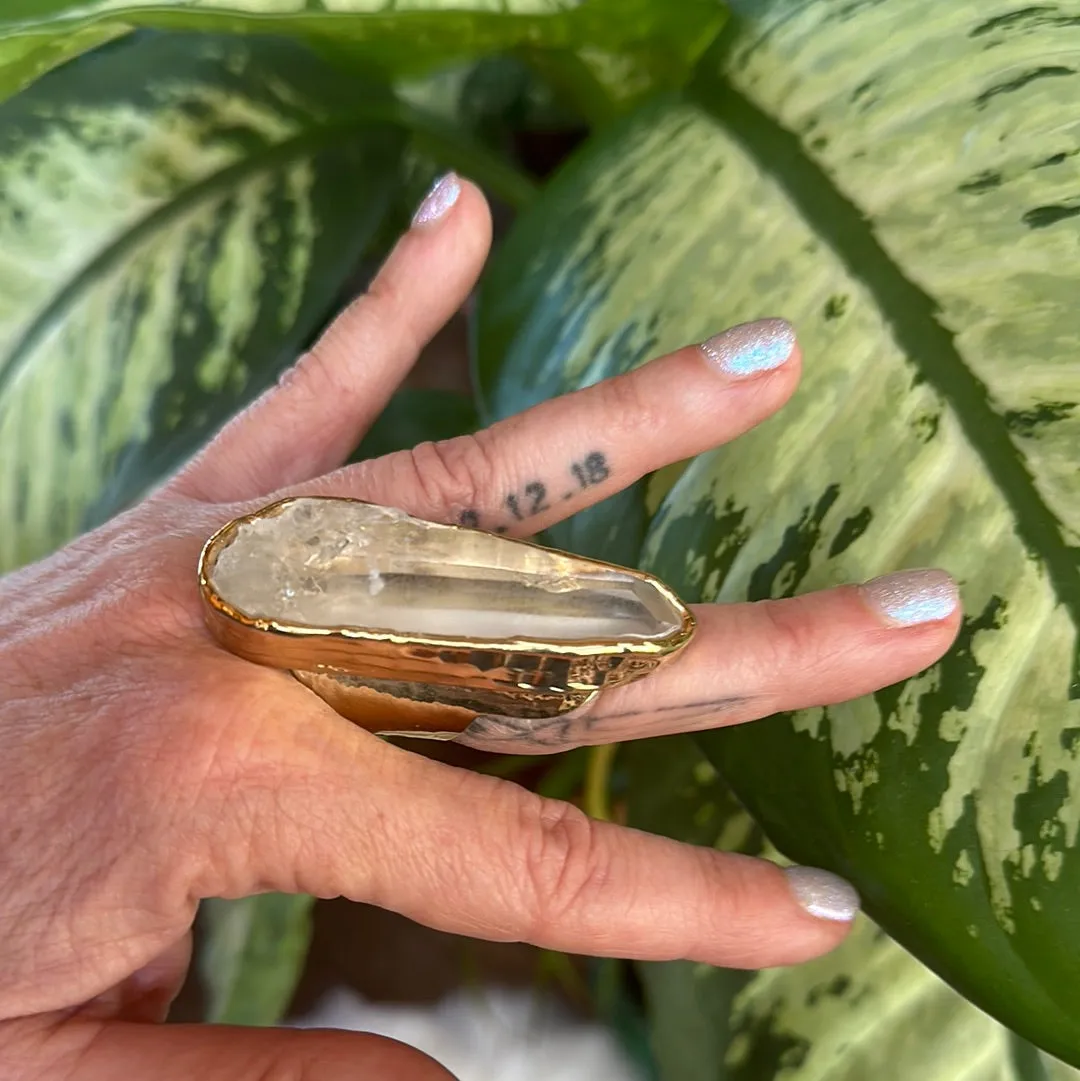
[{"xmin": 199, "ymin": 499, "xmax": 694, "ymax": 738}]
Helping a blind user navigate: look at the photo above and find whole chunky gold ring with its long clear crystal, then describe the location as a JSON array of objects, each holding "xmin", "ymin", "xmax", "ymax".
[{"xmin": 199, "ymin": 497, "xmax": 694, "ymax": 739}]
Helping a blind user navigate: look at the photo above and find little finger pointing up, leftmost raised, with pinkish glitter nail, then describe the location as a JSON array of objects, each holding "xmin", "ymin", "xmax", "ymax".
[{"xmin": 173, "ymin": 174, "xmax": 491, "ymax": 503}]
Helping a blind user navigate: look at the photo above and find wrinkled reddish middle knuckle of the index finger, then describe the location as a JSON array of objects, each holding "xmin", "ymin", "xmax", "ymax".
[{"xmin": 524, "ymin": 796, "xmax": 611, "ymax": 942}]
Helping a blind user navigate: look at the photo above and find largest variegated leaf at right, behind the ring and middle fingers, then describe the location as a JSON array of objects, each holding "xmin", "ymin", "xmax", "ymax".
[{"xmin": 479, "ymin": 0, "xmax": 1080, "ymax": 1063}]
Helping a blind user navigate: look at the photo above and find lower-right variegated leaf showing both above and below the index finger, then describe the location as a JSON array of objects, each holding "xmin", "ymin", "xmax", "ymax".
[{"xmin": 622, "ymin": 736, "xmax": 1080, "ymax": 1081}]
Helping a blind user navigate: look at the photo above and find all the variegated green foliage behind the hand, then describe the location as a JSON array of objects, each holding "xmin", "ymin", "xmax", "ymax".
[{"xmin": 6, "ymin": 0, "xmax": 1080, "ymax": 1081}]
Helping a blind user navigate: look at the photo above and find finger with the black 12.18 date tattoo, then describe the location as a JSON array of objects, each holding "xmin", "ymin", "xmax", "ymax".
[{"xmin": 303, "ymin": 319, "xmax": 799, "ymax": 536}]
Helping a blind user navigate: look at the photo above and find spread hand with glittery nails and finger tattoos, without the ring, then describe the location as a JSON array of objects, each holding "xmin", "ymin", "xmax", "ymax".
[{"xmin": 0, "ymin": 179, "xmax": 959, "ymax": 1081}]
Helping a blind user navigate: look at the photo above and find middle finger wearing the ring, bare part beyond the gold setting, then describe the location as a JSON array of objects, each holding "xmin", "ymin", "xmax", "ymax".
[{"xmin": 458, "ymin": 571, "xmax": 960, "ymax": 755}]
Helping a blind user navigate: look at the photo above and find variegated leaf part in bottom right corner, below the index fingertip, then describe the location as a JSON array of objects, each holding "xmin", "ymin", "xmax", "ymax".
[{"xmin": 639, "ymin": 918, "xmax": 1080, "ymax": 1081}]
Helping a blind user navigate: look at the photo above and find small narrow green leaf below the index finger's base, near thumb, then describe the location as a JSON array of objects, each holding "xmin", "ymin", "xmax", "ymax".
[{"xmin": 199, "ymin": 893, "xmax": 315, "ymax": 1025}]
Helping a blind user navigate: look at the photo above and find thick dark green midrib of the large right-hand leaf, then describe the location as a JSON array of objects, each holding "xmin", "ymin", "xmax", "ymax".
[{"xmin": 697, "ymin": 79, "xmax": 1080, "ymax": 698}]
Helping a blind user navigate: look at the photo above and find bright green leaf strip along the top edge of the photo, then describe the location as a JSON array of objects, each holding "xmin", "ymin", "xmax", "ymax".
[{"xmin": 0, "ymin": 0, "xmax": 723, "ymax": 111}]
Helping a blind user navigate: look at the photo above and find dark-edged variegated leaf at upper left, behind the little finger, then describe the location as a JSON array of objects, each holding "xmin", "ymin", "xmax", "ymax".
[{"xmin": 0, "ymin": 36, "xmax": 404, "ymax": 569}]
